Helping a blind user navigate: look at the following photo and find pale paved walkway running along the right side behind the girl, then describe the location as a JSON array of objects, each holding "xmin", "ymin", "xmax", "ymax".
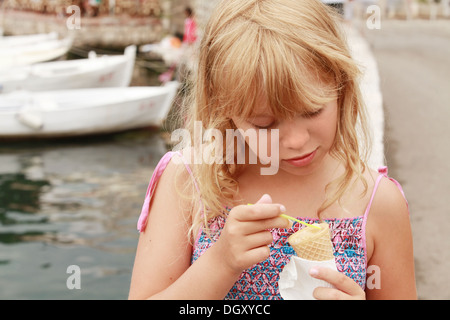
[{"xmin": 366, "ymin": 19, "xmax": 450, "ymax": 299}]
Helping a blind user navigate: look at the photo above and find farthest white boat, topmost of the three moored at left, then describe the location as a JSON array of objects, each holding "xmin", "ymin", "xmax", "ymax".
[{"xmin": 0, "ymin": 37, "xmax": 73, "ymax": 69}]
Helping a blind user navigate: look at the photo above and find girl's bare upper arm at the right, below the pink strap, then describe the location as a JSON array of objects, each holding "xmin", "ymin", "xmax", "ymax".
[{"xmin": 366, "ymin": 179, "xmax": 417, "ymax": 299}]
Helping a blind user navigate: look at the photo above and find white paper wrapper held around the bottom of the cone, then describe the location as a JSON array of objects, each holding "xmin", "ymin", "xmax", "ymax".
[{"xmin": 278, "ymin": 256, "xmax": 337, "ymax": 300}]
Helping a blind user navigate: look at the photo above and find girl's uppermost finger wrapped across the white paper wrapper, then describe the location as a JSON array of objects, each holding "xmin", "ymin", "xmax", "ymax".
[{"xmin": 309, "ymin": 267, "xmax": 362, "ymax": 296}]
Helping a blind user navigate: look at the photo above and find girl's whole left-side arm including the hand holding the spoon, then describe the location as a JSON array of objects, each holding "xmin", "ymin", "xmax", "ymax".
[{"xmin": 129, "ymin": 162, "xmax": 288, "ymax": 299}]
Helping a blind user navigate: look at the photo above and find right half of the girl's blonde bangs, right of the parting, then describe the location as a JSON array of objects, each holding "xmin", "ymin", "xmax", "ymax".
[{"xmin": 259, "ymin": 31, "xmax": 337, "ymax": 118}]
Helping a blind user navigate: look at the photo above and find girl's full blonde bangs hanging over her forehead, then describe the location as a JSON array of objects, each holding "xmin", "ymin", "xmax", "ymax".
[{"xmin": 210, "ymin": 23, "xmax": 338, "ymax": 119}]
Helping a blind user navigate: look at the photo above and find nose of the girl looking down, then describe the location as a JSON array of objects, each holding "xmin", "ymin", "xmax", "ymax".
[{"xmin": 279, "ymin": 120, "xmax": 310, "ymax": 150}]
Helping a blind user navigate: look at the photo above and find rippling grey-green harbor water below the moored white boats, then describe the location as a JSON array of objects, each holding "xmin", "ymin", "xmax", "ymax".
[{"xmin": 0, "ymin": 129, "xmax": 167, "ymax": 299}]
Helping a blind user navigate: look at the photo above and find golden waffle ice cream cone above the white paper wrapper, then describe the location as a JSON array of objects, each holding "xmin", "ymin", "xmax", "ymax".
[{"xmin": 288, "ymin": 223, "xmax": 334, "ymax": 261}]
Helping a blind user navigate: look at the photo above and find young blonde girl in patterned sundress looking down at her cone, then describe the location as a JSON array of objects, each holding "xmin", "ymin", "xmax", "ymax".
[{"xmin": 129, "ymin": 0, "xmax": 416, "ymax": 299}]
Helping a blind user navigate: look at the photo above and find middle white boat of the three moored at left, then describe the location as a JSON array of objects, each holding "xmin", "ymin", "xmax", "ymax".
[{"xmin": 0, "ymin": 45, "xmax": 136, "ymax": 93}]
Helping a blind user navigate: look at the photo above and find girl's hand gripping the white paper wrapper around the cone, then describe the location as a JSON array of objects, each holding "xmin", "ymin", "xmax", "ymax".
[{"xmin": 309, "ymin": 267, "xmax": 366, "ymax": 300}]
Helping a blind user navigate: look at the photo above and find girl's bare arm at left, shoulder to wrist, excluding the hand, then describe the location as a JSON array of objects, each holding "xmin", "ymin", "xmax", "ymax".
[{"xmin": 129, "ymin": 161, "xmax": 234, "ymax": 299}]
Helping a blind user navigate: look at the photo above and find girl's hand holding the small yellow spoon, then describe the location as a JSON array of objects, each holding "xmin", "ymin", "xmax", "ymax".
[{"xmin": 215, "ymin": 195, "xmax": 290, "ymax": 274}]
